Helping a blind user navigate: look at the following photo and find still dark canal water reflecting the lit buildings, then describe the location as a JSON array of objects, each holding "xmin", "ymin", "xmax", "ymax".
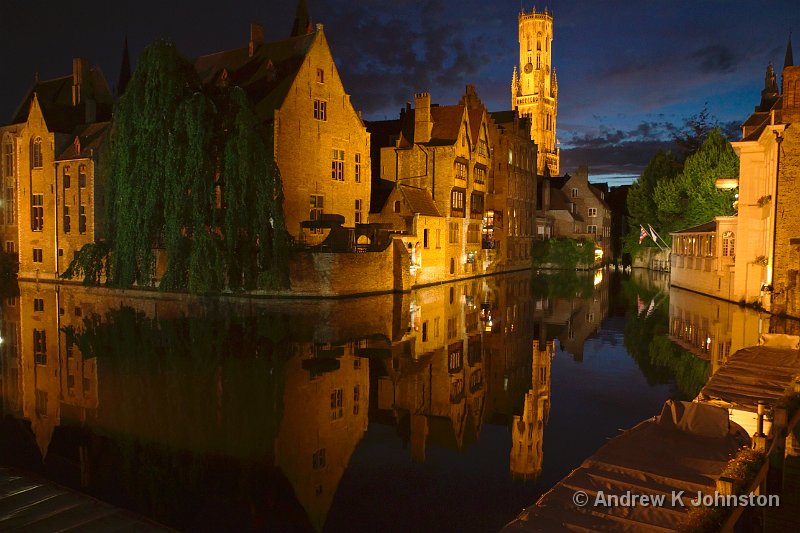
[{"xmin": 0, "ymin": 270, "xmax": 769, "ymax": 532}]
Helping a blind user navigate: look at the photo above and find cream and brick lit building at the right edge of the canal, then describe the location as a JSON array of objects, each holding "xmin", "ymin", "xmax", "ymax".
[{"xmin": 671, "ymin": 42, "xmax": 800, "ymax": 316}]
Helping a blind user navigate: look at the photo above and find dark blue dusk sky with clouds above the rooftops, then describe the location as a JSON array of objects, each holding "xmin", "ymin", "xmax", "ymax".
[{"xmin": 0, "ymin": 0, "xmax": 800, "ymax": 183}]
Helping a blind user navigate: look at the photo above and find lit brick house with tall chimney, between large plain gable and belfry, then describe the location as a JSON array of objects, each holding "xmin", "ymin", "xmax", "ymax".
[{"xmin": 369, "ymin": 85, "xmax": 494, "ymax": 281}]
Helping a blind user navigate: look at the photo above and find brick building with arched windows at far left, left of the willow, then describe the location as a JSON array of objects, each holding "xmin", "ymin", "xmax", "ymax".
[{"xmin": 0, "ymin": 59, "xmax": 112, "ymax": 279}]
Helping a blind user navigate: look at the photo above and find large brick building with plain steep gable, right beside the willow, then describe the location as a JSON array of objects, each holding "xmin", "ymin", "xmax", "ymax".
[{"xmin": 195, "ymin": 15, "xmax": 371, "ymax": 245}]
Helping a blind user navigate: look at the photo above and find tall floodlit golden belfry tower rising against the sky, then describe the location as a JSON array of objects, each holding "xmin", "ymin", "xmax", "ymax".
[{"xmin": 511, "ymin": 8, "xmax": 560, "ymax": 176}]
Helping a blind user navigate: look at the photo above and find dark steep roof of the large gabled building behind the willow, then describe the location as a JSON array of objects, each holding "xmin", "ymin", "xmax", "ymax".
[{"xmin": 194, "ymin": 30, "xmax": 319, "ymax": 121}]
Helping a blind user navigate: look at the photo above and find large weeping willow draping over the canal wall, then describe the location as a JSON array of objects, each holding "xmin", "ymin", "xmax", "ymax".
[{"xmin": 77, "ymin": 40, "xmax": 289, "ymax": 292}]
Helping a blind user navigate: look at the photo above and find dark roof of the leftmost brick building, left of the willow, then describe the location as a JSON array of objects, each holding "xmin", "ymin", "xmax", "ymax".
[{"xmin": 11, "ymin": 66, "xmax": 113, "ymax": 133}]
